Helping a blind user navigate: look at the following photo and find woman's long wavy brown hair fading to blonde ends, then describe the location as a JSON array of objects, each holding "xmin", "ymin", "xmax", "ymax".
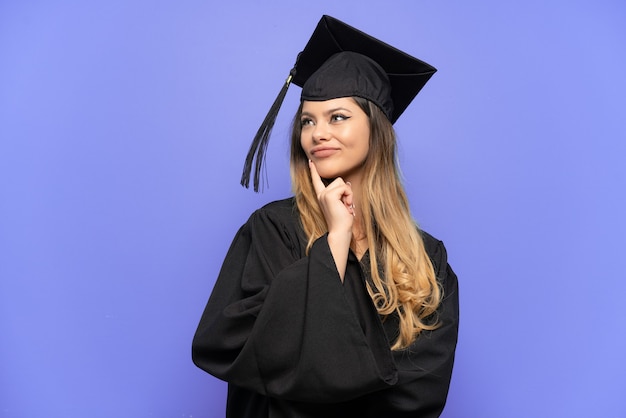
[{"xmin": 290, "ymin": 97, "xmax": 443, "ymax": 350}]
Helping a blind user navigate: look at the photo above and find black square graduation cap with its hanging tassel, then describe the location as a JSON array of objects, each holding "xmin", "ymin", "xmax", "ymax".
[{"xmin": 241, "ymin": 15, "xmax": 437, "ymax": 191}]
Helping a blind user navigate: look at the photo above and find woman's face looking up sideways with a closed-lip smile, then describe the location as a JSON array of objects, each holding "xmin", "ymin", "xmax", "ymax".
[{"xmin": 300, "ymin": 97, "xmax": 370, "ymax": 180}]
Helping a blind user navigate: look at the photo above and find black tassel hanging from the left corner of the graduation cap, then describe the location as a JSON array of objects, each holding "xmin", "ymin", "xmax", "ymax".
[{"xmin": 241, "ymin": 67, "xmax": 296, "ymax": 192}]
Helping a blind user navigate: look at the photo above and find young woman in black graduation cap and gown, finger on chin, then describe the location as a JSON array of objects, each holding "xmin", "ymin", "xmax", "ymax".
[{"xmin": 193, "ymin": 16, "xmax": 458, "ymax": 418}]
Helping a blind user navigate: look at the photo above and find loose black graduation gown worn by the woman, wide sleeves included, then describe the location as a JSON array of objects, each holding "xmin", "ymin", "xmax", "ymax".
[{"xmin": 192, "ymin": 198, "xmax": 458, "ymax": 418}]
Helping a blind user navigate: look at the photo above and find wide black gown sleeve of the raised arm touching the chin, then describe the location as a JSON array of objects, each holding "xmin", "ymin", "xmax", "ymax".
[{"xmin": 192, "ymin": 209, "xmax": 398, "ymax": 403}]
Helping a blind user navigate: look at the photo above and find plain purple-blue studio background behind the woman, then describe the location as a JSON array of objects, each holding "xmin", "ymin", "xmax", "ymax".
[{"xmin": 0, "ymin": 0, "xmax": 626, "ymax": 418}]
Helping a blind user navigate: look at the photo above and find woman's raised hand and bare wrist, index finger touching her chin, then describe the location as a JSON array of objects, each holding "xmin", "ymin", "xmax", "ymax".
[{"xmin": 309, "ymin": 161, "xmax": 354, "ymax": 281}]
